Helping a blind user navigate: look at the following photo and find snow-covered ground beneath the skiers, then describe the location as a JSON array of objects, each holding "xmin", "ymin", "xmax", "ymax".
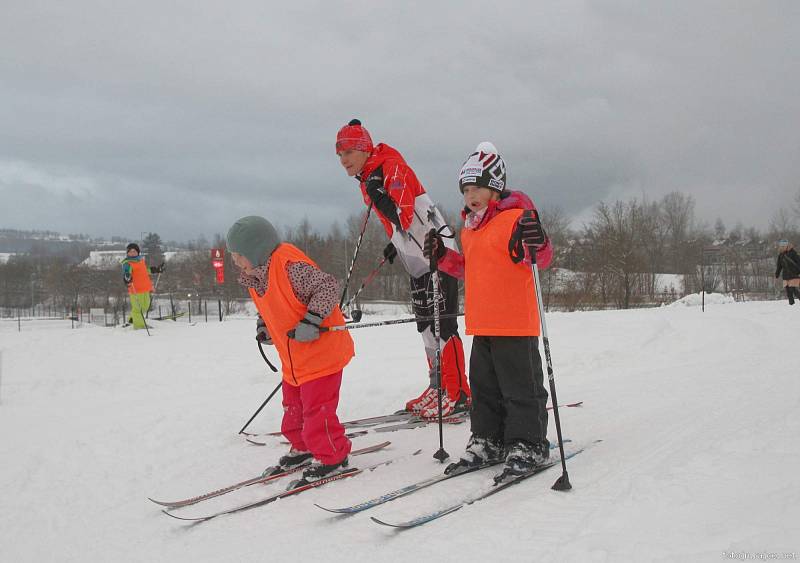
[{"xmin": 0, "ymin": 301, "xmax": 800, "ymax": 563}]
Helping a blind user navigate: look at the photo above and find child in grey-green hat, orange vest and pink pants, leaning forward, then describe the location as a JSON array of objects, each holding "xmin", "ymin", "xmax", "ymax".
[{"xmin": 227, "ymin": 216, "xmax": 354, "ymax": 482}]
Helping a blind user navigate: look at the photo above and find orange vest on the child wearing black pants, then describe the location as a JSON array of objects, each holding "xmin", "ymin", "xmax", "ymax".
[{"xmin": 461, "ymin": 209, "xmax": 541, "ymax": 336}]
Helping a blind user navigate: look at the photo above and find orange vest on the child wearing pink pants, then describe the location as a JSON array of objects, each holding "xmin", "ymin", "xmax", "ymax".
[{"xmin": 250, "ymin": 243, "xmax": 355, "ymax": 387}]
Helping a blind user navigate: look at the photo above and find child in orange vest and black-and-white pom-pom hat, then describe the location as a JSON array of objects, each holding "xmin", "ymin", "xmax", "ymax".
[{"xmin": 425, "ymin": 142, "xmax": 553, "ymax": 475}]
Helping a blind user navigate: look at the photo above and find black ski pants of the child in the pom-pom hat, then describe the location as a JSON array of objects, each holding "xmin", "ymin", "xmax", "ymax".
[{"xmin": 469, "ymin": 336, "xmax": 549, "ymax": 446}]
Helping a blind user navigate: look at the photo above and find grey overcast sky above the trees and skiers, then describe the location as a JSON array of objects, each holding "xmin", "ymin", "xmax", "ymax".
[{"xmin": 0, "ymin": 0, "xmax": 800, "ymax": 240}]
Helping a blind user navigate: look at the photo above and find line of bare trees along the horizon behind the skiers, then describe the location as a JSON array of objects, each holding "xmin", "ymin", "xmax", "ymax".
[{"xmin": 0, "ymin": 192, "xmax": 800, "ymax": 318}]
